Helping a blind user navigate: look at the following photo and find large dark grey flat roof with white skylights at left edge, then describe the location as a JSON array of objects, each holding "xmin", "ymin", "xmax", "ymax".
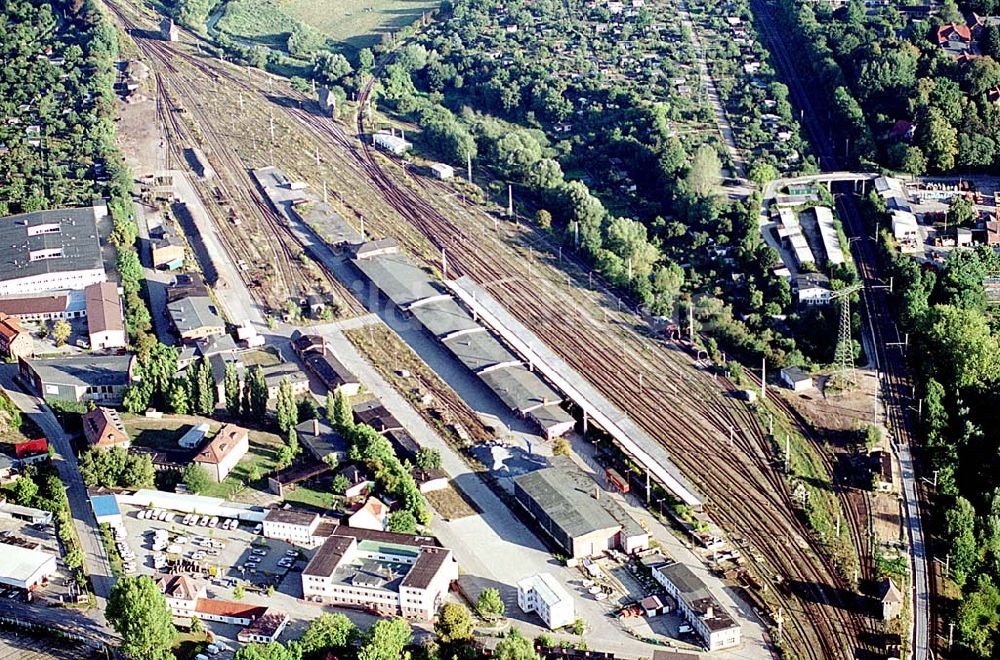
[{"xmin": 0, "ymin": 207, "xmax": 104, "ymax": 280}]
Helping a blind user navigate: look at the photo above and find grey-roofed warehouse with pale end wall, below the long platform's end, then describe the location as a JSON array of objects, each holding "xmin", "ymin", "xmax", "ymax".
[{"xmin": 514, "ymin": 457, "xmax": 649, "ymax": 559}]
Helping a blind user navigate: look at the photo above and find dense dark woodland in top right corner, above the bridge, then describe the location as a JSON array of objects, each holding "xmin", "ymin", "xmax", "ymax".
[{"xmin": 782, "ymin": 0, "xmax": 1000, "ymax": 174}]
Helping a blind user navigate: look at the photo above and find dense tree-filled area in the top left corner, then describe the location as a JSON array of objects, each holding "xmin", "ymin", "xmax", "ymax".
[{"xmin": 0, "ymin": 0, "xmax": 130, "ymax": 215}]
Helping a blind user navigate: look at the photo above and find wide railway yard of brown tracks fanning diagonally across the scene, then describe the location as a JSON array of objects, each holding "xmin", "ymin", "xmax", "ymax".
[{"xmin": 101, "ymin": 3, "xmax": 877, "ymax": 659}]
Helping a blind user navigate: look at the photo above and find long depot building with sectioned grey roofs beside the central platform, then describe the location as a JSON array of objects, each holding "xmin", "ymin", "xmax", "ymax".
[{"xmin": 354, "ymin": 246, "xmax": 575, "ymax": 439}]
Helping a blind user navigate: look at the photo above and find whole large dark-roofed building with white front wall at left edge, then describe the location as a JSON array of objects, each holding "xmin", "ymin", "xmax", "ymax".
[{"xmin": 0, "ymin": 204, "xmax": 108, "ymax": 296}]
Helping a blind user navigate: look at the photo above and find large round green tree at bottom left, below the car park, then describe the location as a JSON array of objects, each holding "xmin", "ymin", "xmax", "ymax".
[{"xmin": 105, "ymin": 575, "xmax": 177, "ymax": 660}]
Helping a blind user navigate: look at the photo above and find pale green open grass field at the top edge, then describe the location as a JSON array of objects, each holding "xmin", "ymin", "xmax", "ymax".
[{"xmin": 217, "ymin": 0, "xmax": 440, "ymax": 50}]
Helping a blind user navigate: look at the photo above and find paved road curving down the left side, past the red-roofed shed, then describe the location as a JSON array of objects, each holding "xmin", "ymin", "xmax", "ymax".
[{"xmin": 0, "ymin": 364, "xmax": 115, "ymax": 626}]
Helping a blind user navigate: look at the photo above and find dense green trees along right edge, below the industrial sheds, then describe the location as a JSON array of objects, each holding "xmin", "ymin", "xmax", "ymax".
[{"xmin": 885, "ymin": 211, "xmax": 1000, "ymax": 658}]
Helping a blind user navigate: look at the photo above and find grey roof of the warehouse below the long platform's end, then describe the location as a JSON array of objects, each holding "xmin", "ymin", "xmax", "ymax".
[{"xmin": 514, "ymin": 464, "xmax": 619, "ymax": 538}]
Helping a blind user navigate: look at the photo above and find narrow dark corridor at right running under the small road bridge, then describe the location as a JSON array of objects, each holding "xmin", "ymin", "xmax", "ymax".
[{"xmin": 752, "ymin": 0, "xmax": 931, "ymax": 660}]
